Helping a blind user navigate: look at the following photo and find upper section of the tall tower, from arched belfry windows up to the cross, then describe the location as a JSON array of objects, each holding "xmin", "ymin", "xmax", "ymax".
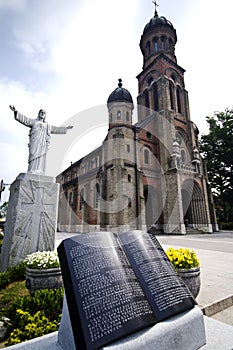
[{"xmin": 137, "ymin": 2, "xmax": 189, "ymax": 121}]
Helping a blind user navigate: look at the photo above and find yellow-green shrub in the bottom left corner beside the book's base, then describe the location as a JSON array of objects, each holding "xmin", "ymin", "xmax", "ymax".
[{"xmin": 5, "ymin": 309, "xmax": 60, "ymax": 346}]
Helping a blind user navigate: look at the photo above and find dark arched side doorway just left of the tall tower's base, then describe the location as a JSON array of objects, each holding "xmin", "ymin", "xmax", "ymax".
[{"xmin": 144, "ymin": 185, "xmax": 159, "ymax": 229}]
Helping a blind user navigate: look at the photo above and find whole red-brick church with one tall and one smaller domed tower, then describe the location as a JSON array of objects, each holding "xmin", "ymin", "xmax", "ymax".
[{"xmin": 57, "ymin": 6, "xmax": 218, "ymax": 234}]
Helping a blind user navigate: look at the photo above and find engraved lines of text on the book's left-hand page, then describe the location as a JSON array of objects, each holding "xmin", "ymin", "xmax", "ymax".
[{"xmin": 70, "ymin": 237, "xmax": 153, "ymax": 342}]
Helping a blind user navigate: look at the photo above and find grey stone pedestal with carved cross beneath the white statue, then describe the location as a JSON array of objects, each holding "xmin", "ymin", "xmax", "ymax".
[{"xmin": 0, "ymin": 173, "xmax": 59, "ymax": 271}]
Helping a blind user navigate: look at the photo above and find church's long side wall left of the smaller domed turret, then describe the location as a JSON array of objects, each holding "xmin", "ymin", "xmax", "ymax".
[{"xmin": 57, "ymin": 148, "xmax": 102, "ymax": 232}]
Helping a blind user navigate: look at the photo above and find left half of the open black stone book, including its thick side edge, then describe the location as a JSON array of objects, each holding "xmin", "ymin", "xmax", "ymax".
[{"xmin": 58, "ymin": 232, "xmax": 155, "ymax": 350}]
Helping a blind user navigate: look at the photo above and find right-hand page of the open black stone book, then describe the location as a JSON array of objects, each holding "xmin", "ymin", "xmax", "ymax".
[{"xmin": 119, "ymin": 231, "xmax": 195, "ymax": 321}]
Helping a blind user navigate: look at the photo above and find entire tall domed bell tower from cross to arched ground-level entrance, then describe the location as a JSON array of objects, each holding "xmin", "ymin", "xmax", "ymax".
[{"xmin": 137, "ymin": 1, "xmax": 215, "ymax": 234}]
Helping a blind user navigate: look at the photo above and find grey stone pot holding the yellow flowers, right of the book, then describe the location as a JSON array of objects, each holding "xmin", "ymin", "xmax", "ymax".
[{"xmin": 177, "ymin": 266, "xmax": 201, "ymax": 298}]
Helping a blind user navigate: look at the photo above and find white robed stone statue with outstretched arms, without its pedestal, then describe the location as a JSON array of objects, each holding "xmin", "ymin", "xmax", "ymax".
[{"xmin": 10, "ymin": 106, "xmax": 73, "ymax": 175}]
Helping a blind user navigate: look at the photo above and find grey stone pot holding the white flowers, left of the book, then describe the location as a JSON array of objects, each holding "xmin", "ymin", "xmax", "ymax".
[{"xmin": 26, "ymin": 267, "xmax": 63, "ymax": 293}]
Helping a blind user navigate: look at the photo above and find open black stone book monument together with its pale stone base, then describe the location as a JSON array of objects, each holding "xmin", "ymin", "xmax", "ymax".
[{"xmin": 58, "ymin": 231, "xmax": 206, "ymax": 350}]
